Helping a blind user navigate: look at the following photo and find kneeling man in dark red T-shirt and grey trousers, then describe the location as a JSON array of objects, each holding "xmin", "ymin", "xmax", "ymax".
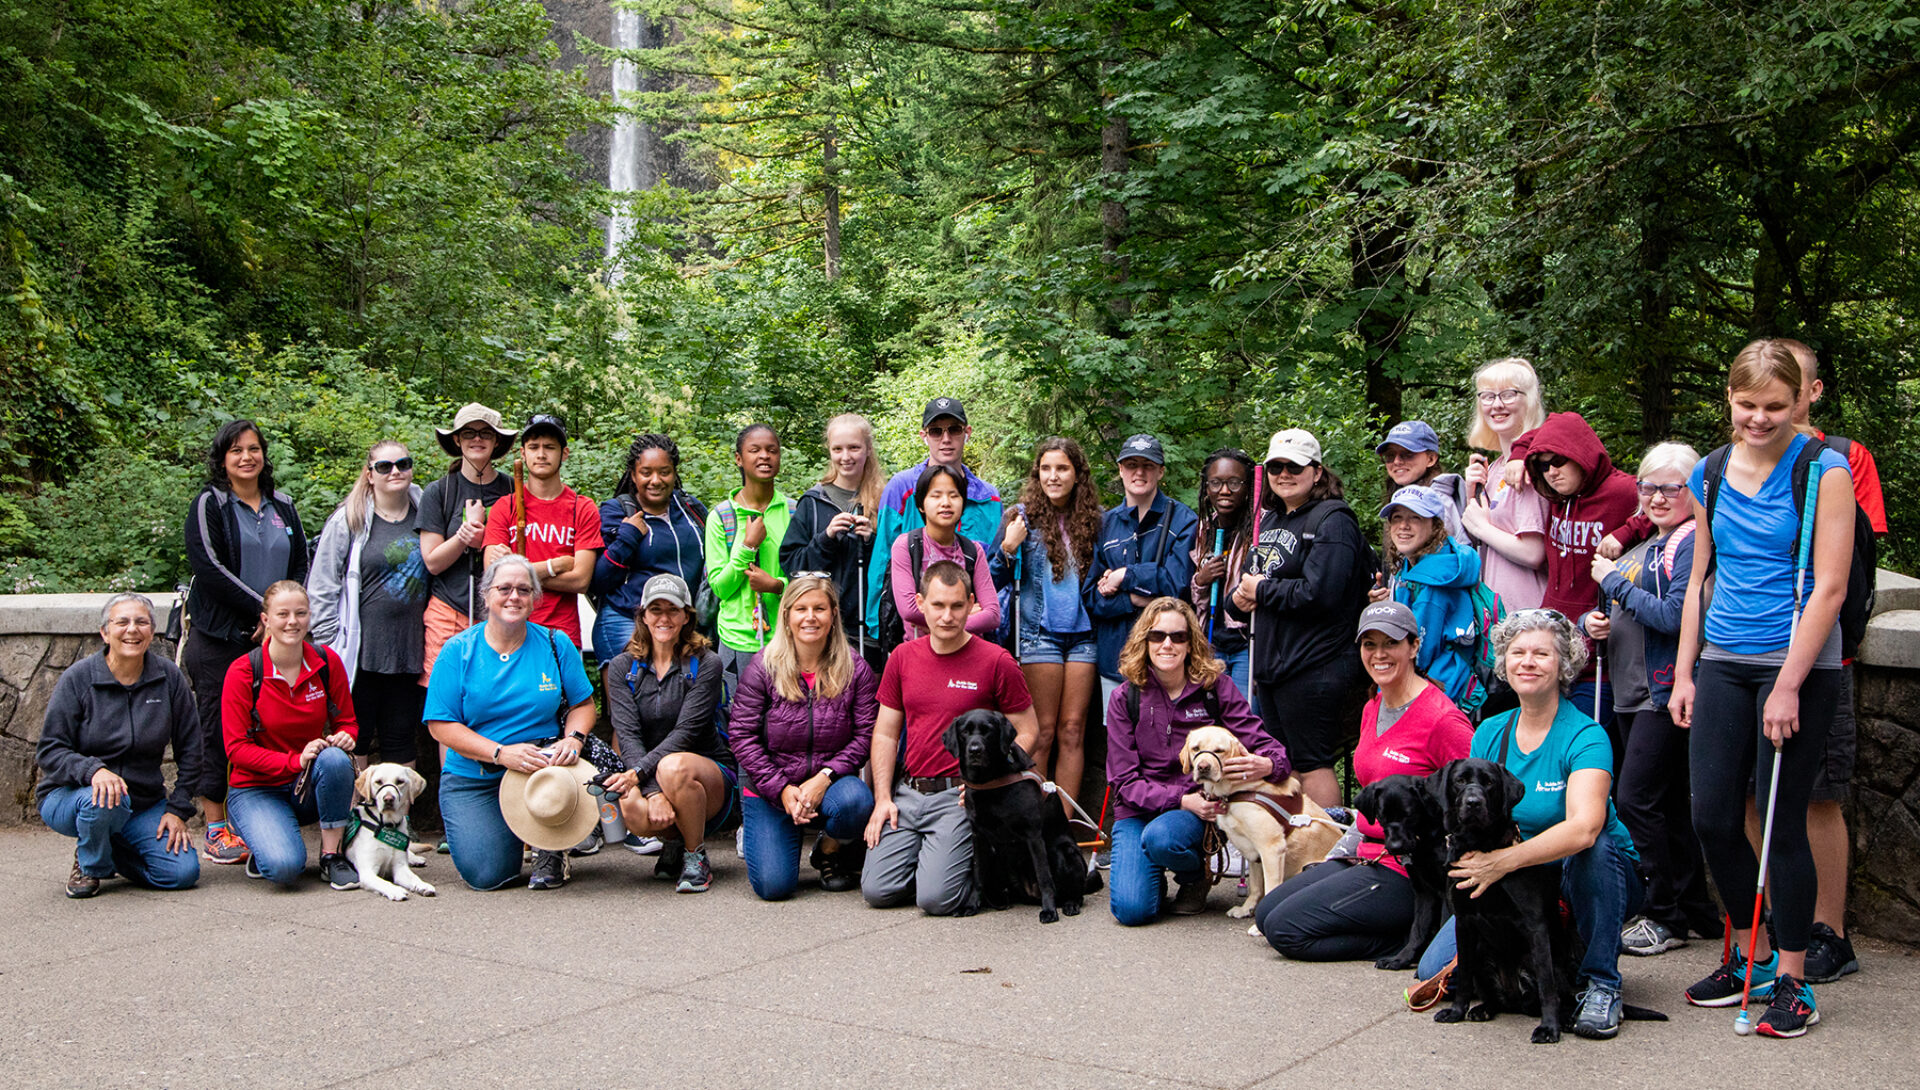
[{"xmin": 860, "ymin": 560, "xmax": 1041, "ymax": 915}]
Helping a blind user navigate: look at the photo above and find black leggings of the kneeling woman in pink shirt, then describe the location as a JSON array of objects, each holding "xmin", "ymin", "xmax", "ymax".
[{"xmin": 1254, "ymin": 860, "xmax": 1413, "ymax": 961}]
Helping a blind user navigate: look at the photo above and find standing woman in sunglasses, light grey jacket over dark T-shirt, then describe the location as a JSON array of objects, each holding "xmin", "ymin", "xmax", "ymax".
[{"xmin": 307, "ymin": 439, "xmax": 428, "ymax": 768}]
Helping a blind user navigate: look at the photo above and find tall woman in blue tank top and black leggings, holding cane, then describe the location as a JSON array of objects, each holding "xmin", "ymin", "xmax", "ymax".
[{"xmin": 1668, "ymin": 338, "xmax": 1857, "ymax": 1036}]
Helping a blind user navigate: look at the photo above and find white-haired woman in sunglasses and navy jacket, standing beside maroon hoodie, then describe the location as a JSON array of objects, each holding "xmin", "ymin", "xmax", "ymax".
[{"xmin": 1580, "ymin": 443, "xmax": 1724, "ymax": 958}]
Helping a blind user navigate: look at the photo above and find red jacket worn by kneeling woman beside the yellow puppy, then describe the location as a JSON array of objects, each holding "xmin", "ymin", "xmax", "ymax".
[{"xmin": 221, "ymin": 643, "xmax": 359, "ymax": 787}]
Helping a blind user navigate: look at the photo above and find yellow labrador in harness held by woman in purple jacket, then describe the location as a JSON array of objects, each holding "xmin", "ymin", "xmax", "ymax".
[{"xmin": 1181, "ymin": 727, "xmax": 1340, "ymax": 919}]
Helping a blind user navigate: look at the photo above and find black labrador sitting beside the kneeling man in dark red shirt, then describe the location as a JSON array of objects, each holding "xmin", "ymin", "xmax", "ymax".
[{"xmin": 941, "ymin": 712, "xmax": 1100, "ymax": 923}]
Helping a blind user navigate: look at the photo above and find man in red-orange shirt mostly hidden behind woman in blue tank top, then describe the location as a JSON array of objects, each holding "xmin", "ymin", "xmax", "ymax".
[{"xmin": 1774, "ymin": 340, "xmax": 1887, "ymax": 984}]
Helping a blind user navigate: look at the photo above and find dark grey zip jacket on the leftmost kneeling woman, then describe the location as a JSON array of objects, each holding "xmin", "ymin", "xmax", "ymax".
[{"xmin": 35, "ymin": 651, "xmax": 204, "ymax": 818}]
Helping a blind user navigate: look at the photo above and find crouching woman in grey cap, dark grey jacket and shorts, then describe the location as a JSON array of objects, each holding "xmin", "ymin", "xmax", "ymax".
[{"xmin": 607, "ymin": 576, "xmax": 739, "ymax": 892}]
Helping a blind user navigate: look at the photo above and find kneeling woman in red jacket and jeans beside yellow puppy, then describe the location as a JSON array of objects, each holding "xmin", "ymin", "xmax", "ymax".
[{"xmin": 221, "ymin": 580, "xmax": 359, "ymax": 889}]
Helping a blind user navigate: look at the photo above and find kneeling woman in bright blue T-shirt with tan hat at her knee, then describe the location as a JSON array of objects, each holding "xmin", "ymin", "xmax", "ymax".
[{"xmin": 424, "ymin": 553, "xmax": 593, "ymax": 890}]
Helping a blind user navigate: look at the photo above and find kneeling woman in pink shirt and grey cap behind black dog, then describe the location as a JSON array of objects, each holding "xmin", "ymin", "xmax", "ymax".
[{"xmin": 1254, "ymin": 603, "xmax": 1473, "ymax": 961}]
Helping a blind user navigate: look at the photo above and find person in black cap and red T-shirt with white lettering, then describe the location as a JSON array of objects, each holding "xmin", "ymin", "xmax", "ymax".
[{"xmin": 484, "ymin": 413, "xmax": 605, "ymax": 647}]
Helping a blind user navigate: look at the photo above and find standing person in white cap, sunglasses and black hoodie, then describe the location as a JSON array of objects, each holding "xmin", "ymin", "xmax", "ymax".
[{"xmin": 1233, "ymin": 428, "xmax": 1377, "ymax": 806}]
